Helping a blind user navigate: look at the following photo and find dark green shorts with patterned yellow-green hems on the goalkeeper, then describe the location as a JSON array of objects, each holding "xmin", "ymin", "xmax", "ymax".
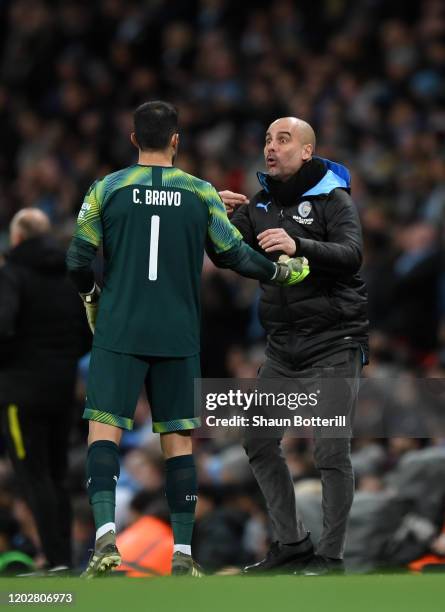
[{"xmin": 83, "ymin": 347, "xmax": 201, "ymax": 433}]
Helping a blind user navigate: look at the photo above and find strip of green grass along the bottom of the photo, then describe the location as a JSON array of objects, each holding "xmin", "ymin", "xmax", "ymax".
[{"xmin": 0, "ymin": 574, "xmax": 445, "ymax": 612}]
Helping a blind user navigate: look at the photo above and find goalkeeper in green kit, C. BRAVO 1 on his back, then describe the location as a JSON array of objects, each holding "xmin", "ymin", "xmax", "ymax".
[{"xmin": 67, "ymin": 102, "xmax": 309, "ymax": 577}]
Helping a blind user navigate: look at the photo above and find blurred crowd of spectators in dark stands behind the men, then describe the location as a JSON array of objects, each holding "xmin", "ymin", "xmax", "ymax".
[{"xmin": 0, "ymin": 0, "xmax": 445, "ymax": 569}]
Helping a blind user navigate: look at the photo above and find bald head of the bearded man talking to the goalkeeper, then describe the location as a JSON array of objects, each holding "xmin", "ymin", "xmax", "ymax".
[{"xmin": 264, "ymin": 117, "xmax": 315, "ymax": 181}]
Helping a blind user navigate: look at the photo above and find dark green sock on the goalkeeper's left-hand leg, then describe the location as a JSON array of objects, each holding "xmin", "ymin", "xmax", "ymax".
[{"xmin": 87, "ymin": 440, "xmax": 120, "ymax": 540}]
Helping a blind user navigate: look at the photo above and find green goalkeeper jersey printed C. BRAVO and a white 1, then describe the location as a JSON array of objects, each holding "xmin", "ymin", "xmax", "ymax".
[{"xmin": 68, "ymin": 164, "xmax": 246, "ymax": 357}]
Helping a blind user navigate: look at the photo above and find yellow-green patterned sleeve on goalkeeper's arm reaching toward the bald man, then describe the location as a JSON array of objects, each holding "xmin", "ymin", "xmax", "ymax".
[{"xmin": 205, "ymin": 184, "xmax": 243, "ymax": 253}]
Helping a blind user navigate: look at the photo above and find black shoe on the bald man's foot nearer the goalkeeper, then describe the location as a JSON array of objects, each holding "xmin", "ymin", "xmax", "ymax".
[{"xmin": 243, "ymin": 533, "xmax": 314, "ymax": 576}]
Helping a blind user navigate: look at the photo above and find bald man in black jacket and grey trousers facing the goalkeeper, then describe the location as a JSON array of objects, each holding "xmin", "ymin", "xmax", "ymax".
[{"xmin": 220, "ymin": 117, "xmax": 368, "ymax": 575}]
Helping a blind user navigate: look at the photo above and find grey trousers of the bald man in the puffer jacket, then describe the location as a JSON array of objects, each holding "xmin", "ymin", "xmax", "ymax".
[{"xmin": 244, "ymin": 348, "xmax": 362, "ymax": 559}]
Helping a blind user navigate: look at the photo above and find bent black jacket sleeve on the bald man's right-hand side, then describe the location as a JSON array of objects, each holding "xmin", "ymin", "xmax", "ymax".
[{"xmin": 293, "ymin": 189, "xmax": 363, "ymax": 274}]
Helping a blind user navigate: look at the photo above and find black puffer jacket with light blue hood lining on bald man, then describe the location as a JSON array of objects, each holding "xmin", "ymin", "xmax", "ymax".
[{"xmin": 231, "ymin": 158, "xmax": 368, "ymax": 367}]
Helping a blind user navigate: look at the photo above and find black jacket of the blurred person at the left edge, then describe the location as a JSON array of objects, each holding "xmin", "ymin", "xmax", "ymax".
[{"xmin": 0, "ymin": 236, "xmax": 91, "ymax": 410}]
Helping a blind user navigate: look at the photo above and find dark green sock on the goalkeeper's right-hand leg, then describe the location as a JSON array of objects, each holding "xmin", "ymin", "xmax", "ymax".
[{"xmin": 165, "ymin": 455, "xmax": 198, "ymax": 554}]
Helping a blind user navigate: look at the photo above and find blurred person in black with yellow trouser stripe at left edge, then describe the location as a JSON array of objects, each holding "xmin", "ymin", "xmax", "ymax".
[{"xmin": 0, "ymin": 208, "xmax": 88, "ymax": 567}]
